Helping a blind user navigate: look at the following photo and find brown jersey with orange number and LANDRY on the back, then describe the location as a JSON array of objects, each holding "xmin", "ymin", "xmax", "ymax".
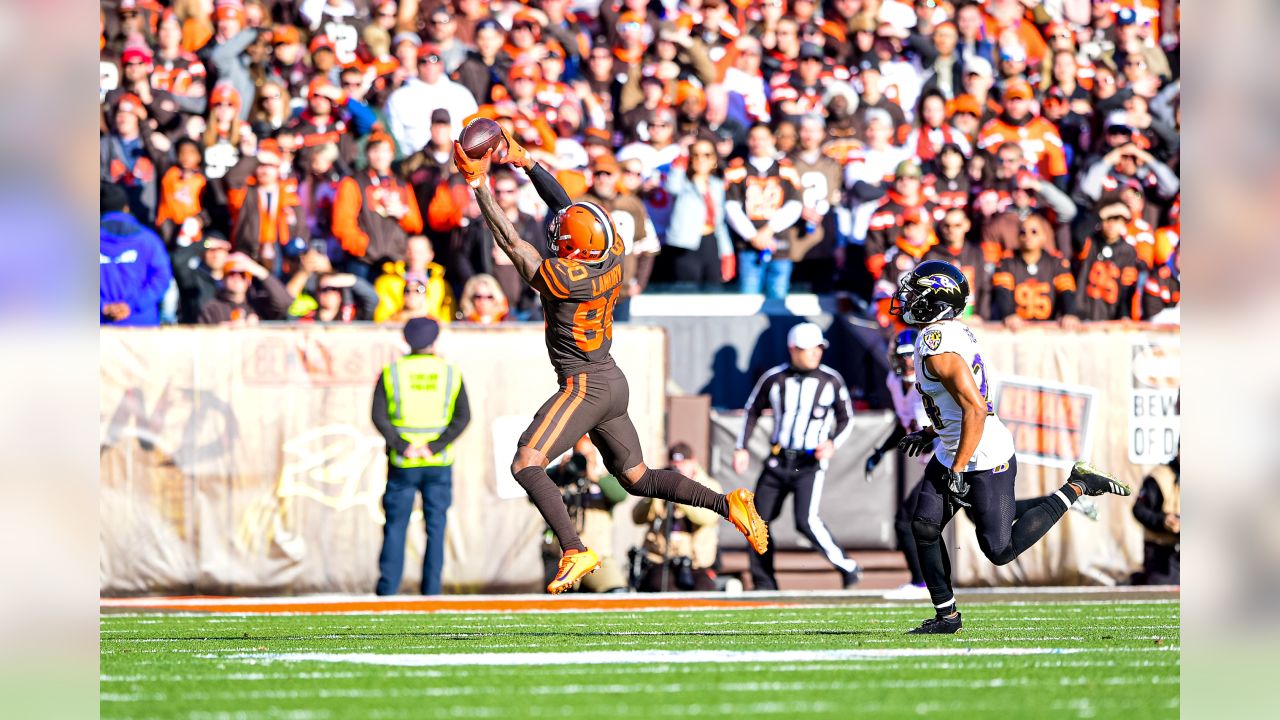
[{"xmin": 530, "ymin": 234, "xmax": 623, "ymax": 375}]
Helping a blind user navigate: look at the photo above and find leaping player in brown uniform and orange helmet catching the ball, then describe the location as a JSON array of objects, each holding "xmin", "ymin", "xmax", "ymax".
[{"xmin": 453, "ymin": 131, "xmax": 769, "ymax": 593}]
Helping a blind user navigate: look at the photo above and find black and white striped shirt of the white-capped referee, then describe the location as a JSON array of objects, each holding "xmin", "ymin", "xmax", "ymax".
[{"xmin": 737, "ymin": 363, "xmax": 852, "ymax": 450}]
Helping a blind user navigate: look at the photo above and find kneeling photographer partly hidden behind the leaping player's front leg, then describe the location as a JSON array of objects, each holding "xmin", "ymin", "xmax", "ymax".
[{"xmin": 543, "ymin": 436, "xmax": 629, "ymax": 592}]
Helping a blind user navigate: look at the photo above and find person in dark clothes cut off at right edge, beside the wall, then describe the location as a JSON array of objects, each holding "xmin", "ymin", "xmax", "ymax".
[{"xmin": 1133, "ymin": 455, "xmax": 1183, "ymax": 585}]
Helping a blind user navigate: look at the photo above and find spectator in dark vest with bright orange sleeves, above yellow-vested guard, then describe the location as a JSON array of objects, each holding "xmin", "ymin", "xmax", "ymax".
[{"xmin": 333, "ymin": 131, "xmax": 422, "ymax": 279}]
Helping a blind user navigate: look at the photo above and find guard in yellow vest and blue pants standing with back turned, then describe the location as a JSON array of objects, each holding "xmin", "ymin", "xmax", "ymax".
[{"xmin": 372, "ymin": 318, "xmax": 471, "ymax": 594}]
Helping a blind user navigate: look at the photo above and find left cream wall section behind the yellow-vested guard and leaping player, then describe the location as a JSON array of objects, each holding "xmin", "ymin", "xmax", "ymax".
[{"xmin": 99, "ymin": 324, "xmax": 667, "ymax": 596}]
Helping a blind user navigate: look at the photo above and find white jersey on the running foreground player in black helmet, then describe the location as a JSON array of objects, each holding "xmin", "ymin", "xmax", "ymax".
[{"xmin": 915, "ymin": 320, "xmax": 1014, "ymax": 471}]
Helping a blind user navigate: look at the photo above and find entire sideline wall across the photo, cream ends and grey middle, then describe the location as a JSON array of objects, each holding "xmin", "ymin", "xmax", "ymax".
[{"xmin": 100, "ymin": 318, "xmax": 1180, "ymax": 596}]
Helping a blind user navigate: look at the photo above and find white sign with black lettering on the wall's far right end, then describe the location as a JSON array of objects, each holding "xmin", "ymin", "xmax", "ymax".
[{"xmin": 1129, "ymin": 336, "xmax": 1181, "ymax": 465}]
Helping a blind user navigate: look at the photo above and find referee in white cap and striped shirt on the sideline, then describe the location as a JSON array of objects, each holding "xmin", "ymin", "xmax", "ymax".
[{"xmin": 733, "ymin": 323, "xmax": 861, "ymax": 591}]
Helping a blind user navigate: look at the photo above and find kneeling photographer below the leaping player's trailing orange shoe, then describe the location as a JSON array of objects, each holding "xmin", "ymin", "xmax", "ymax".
[{"xmin": 631, "ymin": 442, "xmax": 722, "ymax": 592}]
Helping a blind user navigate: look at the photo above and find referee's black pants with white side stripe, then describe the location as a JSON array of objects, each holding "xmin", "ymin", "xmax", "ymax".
[{"xmin": 749, "ymin": 451, "xmax": 858, "ymax": 591}]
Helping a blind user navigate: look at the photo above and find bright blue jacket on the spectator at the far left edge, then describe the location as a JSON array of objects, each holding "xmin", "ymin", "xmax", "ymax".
[{"xmin": 97, "ymin": 213, "xmax": 173, "ymax": 325}]
